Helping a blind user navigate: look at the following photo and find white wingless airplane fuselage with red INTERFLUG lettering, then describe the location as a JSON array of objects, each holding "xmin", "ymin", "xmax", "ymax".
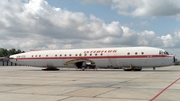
[{"xmin": 10, "ymin": 47, "xmax": 175, "ymax": 71}]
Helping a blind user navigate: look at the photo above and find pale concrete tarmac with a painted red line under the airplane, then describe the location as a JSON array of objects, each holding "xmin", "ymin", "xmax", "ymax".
[{"xmin": 0, "ymin": 66, "xmax": 180, "ymax": 101}]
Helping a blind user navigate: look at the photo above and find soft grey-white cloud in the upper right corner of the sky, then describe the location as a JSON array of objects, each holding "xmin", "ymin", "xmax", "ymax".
[{"xmin": 112, "ymin": 0, "xmax": 180, "ymax": 17}]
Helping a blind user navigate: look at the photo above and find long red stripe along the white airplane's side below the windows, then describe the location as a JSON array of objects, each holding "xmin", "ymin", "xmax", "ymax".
[{"xmin": 15, "ymin": 55, "xmax": 173, "ymax": 60}]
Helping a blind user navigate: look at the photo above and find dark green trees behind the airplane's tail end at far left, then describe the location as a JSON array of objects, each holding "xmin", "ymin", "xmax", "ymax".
[{"xmin": 0, "ymin": 48, "xmax": 24, "ymax": 57}]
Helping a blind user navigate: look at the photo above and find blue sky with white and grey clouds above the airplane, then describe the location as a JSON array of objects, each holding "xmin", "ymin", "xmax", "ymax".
[{"xmin": 0, "ymin": 0, "xmax": 180, "ymax": 58}]
